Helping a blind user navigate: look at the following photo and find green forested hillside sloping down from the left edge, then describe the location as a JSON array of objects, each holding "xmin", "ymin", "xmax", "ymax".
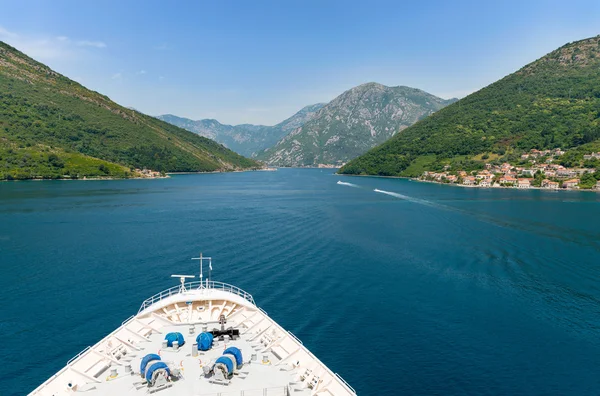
[{"xmin": 0, "ymin": 42, "xmax": 258, "ymax": 180}]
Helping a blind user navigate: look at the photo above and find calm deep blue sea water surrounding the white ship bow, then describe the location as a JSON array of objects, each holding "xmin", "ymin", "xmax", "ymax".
[{"xmin": 0, "ymin": 169, "xmax": 600, "ymax": 396}]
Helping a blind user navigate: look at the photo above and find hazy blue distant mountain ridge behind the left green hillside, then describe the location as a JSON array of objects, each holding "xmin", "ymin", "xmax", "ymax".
[{"xmin": 156, "ymin": 103, "xmax": 324, "ymax": 157}]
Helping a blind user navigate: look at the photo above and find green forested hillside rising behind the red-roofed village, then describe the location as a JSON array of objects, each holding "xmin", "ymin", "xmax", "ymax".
[{"xmin": 340, "ymin": 36, "xmax": 600, "ymax": 176}]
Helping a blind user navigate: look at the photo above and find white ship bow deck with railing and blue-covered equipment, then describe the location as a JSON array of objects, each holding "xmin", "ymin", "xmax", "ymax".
[{"xmin": 31, "ymin": 282, "xmax": 356, "ymax": 396}]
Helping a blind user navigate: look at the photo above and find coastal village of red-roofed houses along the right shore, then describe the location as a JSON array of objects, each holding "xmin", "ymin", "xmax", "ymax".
[{"xmin": 419, "ymin": 148, "xmax": 600, "ymax": 192}]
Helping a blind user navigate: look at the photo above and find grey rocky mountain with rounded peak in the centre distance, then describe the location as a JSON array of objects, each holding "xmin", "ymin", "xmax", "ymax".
[{"xmin": 257, "ymin": 83, "xmax": 456, "ymax": 166}]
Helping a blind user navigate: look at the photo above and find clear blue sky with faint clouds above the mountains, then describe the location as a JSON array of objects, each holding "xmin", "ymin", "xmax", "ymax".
[{"xmin": 0, "ymin": 0, "xmax": 600, "ymax": 125}]
